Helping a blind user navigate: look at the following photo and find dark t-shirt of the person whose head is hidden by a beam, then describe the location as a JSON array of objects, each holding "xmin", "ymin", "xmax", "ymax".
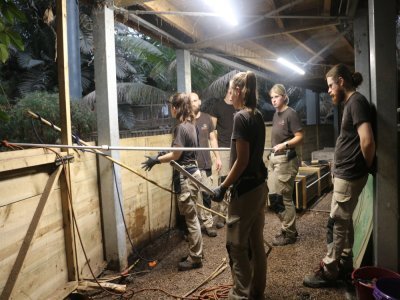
[{"xmin": 210, "ymin": 99, "xmax": 236, "ymax": 147}]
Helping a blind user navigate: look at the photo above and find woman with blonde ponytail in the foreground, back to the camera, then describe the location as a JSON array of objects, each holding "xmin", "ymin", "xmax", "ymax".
[{"xmin": 213, "ymin": 71, "xmax": 267, "ymax": 299}]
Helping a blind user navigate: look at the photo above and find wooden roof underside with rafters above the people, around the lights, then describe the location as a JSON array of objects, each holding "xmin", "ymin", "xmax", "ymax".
[{"xmin": 108, "ymin": 0, "xmax": 362, "ymax": 89}]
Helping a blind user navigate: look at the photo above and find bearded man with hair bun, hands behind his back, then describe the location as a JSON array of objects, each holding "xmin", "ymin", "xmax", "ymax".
[{"xmin": 303, "ymin": 64, "xmax": 375, "ymax": 288}]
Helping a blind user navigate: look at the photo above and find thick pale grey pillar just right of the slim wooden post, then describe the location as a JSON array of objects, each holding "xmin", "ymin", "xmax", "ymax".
[{"xmin": 93, "ymin": 1, "xmax": 127, "ymax": 271}]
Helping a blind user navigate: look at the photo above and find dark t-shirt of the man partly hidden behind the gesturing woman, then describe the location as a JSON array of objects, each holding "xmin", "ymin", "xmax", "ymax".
[{"xmin": 196, "ymin": 112, "xmax": 214, "ymax": 170}]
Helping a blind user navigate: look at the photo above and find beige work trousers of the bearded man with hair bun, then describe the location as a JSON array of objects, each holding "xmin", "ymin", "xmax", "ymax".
[{"xmin": 322, "ymin": 175, "xmax": 368, "ymax": 278}]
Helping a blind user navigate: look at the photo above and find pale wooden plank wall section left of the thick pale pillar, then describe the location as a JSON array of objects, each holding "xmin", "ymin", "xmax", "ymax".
[{"xmin": 0, "ymin": 149, "xmax": 105, "ymax": 299}]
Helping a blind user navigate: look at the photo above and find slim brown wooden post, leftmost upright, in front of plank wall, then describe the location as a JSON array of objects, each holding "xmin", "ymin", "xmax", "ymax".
[{"xmin": 57, "ymin": 0, "xmax": 78, "ymax": 281}]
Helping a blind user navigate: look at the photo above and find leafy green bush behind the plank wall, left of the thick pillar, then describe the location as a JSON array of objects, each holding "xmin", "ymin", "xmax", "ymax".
[{"xmin": 0, "ymin": 92, "xmax": 95, "ymax": 144}]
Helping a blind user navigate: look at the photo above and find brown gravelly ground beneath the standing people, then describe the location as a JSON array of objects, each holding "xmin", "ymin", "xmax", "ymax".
[{"xmin": 73, "ymin": 193, "xmax": 355, "ymax": 300}]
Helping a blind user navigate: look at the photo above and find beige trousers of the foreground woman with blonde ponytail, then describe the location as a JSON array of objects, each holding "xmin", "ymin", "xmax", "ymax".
[{"xmin": 226, "ymin": 183, "xmax": 268, "ymax": 300}]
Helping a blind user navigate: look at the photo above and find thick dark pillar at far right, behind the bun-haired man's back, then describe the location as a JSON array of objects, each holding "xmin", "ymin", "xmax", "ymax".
[{"xmin": 368, "ymin": 0, "xmax": 400, "ymax": 270}]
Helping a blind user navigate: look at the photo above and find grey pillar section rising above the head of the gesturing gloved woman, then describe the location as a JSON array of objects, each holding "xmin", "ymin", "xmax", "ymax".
[{"xmin": 176, "ymin": 49, "xmax": 192, "ymax": 93}]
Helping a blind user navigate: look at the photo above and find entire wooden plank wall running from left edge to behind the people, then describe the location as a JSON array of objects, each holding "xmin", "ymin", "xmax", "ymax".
[{"xmin": 0, "ymin": 125, "xmax": 333, "ymax": 299}]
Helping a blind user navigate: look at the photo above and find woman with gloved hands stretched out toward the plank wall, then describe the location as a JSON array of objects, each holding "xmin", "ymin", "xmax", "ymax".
[{"xmin": 142, "ymin": 93, "xmax": 203, "ymax": 271}]
